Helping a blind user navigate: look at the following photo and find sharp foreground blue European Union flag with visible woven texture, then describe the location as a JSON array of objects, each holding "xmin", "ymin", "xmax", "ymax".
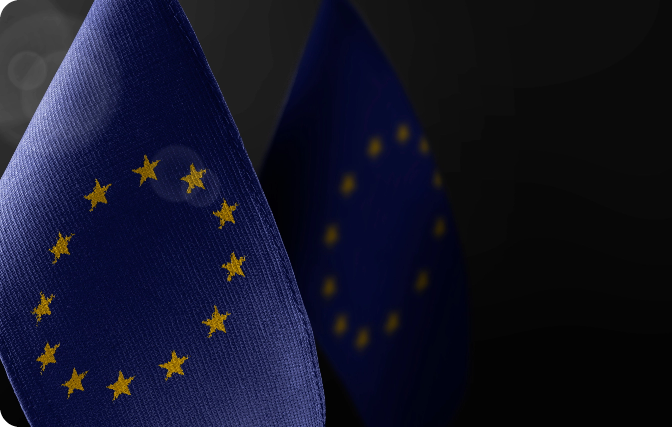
[{"xmin": 0, "ymin": 0, "xmax": 325, "ymax": 427}]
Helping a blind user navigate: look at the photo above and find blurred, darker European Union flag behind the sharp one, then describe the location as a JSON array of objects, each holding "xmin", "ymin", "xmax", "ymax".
[{"xmin": 261, "ymin": 0, "xmax": 468, "ymax": 427}]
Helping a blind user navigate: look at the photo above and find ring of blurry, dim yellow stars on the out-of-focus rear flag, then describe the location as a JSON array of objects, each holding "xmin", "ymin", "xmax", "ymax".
[{"xmin": 320, "ymin": 123, "xmax": 447, "ymax": 351}]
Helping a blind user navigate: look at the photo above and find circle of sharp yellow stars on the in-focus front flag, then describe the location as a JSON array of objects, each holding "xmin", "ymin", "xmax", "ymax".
[{"xmin": 31, "ymin": 155, "xmax": 245, "ymax": 401}]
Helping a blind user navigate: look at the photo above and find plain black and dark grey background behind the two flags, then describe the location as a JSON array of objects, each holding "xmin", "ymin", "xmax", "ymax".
[{"xmin": 0, "ymin": 0, "xmax": 672, "ymax": 426}]
